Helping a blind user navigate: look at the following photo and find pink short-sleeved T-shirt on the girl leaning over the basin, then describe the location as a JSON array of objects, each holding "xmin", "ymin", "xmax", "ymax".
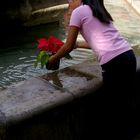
[{"xmin": 70, "ymin": 5, "xmax": 132, "ymax": 65}]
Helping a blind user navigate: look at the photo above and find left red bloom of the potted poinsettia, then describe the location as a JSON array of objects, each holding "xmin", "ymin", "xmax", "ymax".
[{"xmin": 37, "ymin": 38, "xmax": 49, "ymax": 51}]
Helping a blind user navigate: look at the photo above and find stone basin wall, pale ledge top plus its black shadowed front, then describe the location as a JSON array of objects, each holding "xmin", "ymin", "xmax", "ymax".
[{"xmin": 0, "ymin": 58, "xmax": 139, "ymax": 140}]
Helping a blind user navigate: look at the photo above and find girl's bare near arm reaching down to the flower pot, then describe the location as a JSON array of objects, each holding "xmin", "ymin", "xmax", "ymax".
[{"xmin": 48, "ymin": 26, "xmax": 79, "ymax": 69}]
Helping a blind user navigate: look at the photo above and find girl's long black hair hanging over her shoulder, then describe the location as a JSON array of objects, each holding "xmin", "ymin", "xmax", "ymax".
[{"xmin": 82, "ymin": 0, "xmax": 113, "ymax": 24}]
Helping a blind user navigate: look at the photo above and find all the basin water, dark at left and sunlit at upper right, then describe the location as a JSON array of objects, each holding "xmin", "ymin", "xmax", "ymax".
[{"xmin": 0, "ymin": 0, "xmax": 140, "ymax": 89}]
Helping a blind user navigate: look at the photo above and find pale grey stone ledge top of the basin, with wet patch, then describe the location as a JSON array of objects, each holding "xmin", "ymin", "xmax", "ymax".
[{"xmin": 0, "ymin": 61, "xmax": 101, "ymax": 125}]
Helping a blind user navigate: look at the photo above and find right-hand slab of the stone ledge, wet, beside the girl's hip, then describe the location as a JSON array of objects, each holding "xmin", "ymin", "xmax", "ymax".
[{"xmin": 42, "ymin": 60, "xmax": 102, "ymax": 97}]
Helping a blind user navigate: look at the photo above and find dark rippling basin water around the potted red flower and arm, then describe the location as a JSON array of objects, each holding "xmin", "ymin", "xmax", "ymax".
[{"xmin": 0, "ymin": 23, "xmax": 92, "ymax": 88}]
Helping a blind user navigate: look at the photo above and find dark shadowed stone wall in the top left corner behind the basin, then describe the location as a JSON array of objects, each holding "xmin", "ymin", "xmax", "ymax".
[{"xmin": 0, "ymin": 0, "xmax": 67, "ymax": 22}]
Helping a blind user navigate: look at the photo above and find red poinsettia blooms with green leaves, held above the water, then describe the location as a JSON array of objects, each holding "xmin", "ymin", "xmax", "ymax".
[{"xmin": 34, "ymin": 36, "xmax": 72, "ymax": 70}]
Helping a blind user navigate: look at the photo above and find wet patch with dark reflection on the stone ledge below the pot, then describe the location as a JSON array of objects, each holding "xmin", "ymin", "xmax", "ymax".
[{"xmin": 41, "ymin": 67, "xmax": 97, "ymax": 88}]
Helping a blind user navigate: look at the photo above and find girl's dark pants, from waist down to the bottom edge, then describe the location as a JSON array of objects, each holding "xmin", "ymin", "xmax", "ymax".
[{"xmin": 101, "ymin": 50, "xmax": 136, "ymax": 140}]
